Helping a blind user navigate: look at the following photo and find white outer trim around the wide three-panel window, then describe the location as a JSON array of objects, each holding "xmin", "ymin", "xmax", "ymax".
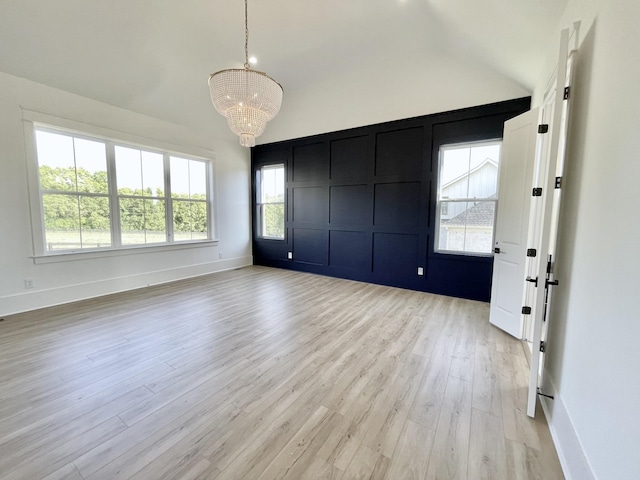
[{"xmin": 22, "ymin": 108, "xmax": 219, "ymax": 264}]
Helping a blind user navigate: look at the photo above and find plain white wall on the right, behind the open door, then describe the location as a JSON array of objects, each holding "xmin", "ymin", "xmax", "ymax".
[{"xmin": 534, "ymin": 0, "xmax": 640, "ymax": 480}]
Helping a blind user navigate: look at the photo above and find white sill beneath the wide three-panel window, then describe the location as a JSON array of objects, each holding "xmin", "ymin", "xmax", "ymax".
[{"xmin": 31, "ymin": 240, "xmax": 218, "ymax": 264}]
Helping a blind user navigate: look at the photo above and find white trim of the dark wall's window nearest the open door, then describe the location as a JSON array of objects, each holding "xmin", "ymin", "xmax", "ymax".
[{"xmin": 433, "ymin": 138, "xmax": 502, "ymax": 257}]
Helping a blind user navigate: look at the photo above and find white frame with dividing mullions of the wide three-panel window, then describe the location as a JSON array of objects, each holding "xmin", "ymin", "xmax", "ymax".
[{"xmin": 23, "ymin": 114, "xmax": 218, "ymax": 263}]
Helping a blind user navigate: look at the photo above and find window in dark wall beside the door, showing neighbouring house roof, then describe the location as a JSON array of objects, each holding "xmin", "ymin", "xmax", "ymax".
[{"xmin": 435, "ymin": 141, "xmax": 502, "ymax": 254}]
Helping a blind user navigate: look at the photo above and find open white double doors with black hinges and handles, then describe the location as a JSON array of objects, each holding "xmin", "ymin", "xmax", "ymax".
[{"xmin": 489, "ymin": 22, "xmax": 580, "ymax": 417}]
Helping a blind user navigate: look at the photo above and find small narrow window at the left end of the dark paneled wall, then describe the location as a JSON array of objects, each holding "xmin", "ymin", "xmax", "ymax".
[{"xmin": 256, "ymin": 164, "xmax": 285, "ymax": 240}]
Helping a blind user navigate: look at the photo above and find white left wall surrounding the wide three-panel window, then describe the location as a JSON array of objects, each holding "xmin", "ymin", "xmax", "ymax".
[{"xmin": 0, "ymin": 73, "xmax": 252, "ymax": 315}]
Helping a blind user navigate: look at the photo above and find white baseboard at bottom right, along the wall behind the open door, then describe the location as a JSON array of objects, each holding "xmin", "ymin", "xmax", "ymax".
[{"xmin": 540, "ymin": 373, "xmax": 596, "ymax": 480}]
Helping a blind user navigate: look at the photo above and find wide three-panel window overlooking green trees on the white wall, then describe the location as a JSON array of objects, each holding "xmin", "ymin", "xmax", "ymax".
[{"xmin": 35, "ymin": 127, "xmax": 211, "ymax": 253}]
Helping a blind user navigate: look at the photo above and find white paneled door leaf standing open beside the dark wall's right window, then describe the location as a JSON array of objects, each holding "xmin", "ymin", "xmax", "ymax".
[{"xmin": 489, "ymin": 108, "xmax": 539, "ymax": 338}]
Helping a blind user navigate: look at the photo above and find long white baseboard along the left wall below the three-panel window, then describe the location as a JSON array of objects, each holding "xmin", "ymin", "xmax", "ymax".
[{"xmin": 0, "ymin": 256, "xmax": 253, "ymax": 316}]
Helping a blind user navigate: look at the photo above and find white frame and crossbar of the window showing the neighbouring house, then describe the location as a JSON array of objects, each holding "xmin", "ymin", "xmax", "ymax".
[{"xmin": 433, "ymin": 138, "xmax": 503, "ymax": 258}]
